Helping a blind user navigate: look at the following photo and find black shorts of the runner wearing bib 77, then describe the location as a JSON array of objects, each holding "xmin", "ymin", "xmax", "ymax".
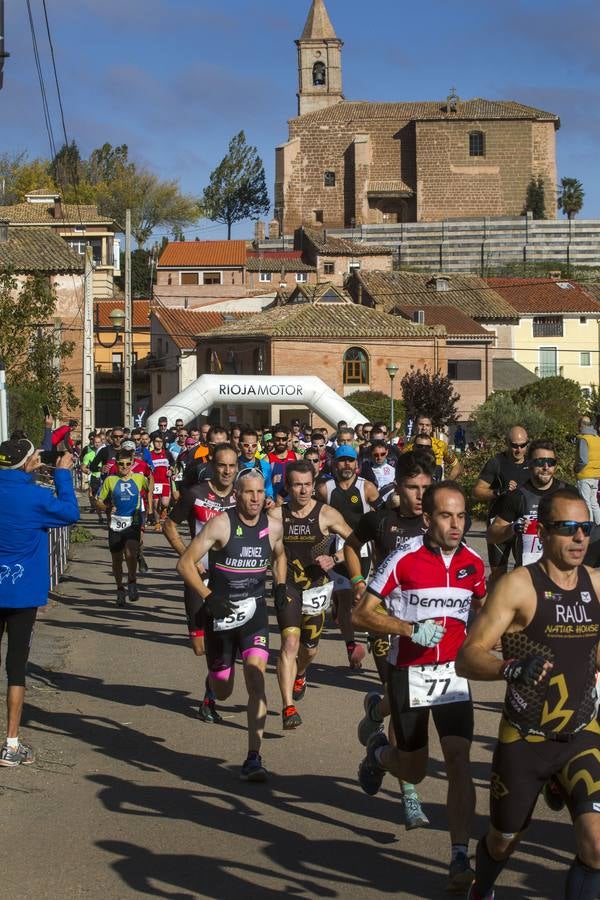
[{"xmin": 387, "ymin": 665, "xmax": 474, "ymax": 753}]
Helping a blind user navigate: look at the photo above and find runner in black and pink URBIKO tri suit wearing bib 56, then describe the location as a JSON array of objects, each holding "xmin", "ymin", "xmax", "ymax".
[{"xmin": 177, "ymin": 468, "xmax": 284, "ymax": 781}]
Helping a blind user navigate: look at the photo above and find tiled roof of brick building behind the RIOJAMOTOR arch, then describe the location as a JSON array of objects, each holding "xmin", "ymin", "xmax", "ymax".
[{"xmin": 203, "ymin": 303, "xmax": 444, "ymax": 340}]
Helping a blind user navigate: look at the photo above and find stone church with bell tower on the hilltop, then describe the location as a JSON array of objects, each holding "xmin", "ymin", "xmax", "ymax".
[{"xmin": 275, "ymin": 0, "xmax": 560, "ymax": 234}]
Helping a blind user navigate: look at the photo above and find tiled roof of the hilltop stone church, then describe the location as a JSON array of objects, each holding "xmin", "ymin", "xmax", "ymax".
[{"xmin": 290, "ymin": 97, "xmax": 560, "ymax": 129}]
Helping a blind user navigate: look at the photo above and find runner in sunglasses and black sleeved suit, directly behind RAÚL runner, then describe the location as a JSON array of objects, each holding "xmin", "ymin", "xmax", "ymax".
[{"xmin": 487, "ymin": 438, "xmax": 567, "ymax": 566}]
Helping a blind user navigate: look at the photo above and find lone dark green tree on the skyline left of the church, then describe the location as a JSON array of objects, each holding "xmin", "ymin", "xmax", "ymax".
[{"xmin": 202, "ymin": 131, "xmax": 270, "ymax": 240}]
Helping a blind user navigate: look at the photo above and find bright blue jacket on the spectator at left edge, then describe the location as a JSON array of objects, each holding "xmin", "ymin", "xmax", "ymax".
[{"xmin": 0, "ymin": 469, "xmax": 79, "ymax": 609}]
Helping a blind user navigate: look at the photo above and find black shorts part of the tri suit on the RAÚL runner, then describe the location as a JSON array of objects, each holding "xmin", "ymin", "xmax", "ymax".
[{"xmin": 490, "ymin": 718, "xmax": 600, "ymax": 835}]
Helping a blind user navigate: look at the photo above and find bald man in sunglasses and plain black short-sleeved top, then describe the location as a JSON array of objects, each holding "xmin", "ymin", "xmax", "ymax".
[{"xmin": 473, "ymin": 425, "xmax": 529, "ymax": 586}]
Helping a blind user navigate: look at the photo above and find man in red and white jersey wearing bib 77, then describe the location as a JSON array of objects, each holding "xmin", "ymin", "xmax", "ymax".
[{"xmin": 352, "ymin": 481, "xmax": 485, "ymax": 892}]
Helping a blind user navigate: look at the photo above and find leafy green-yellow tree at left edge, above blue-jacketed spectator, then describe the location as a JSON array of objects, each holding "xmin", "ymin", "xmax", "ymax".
[{"xmin": 0, "ymin": 272, "xmax": 78, "ymax": 440}]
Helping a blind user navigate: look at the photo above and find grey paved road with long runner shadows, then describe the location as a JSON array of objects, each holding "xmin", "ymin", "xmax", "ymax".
[{"xmin": 0, "ymin": 515, "xmax": 573, "ymax": 900}]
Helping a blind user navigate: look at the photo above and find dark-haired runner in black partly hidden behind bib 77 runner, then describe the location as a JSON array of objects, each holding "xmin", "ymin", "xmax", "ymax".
[{"xmin": 344, "ymin": 450, "xmax": 435, "ymax": 831}]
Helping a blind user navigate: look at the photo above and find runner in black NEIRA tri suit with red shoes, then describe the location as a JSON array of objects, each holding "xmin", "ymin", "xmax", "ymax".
[{"xmin": 270, "ymin": 460, "xmax": 360, "ymax": 730}]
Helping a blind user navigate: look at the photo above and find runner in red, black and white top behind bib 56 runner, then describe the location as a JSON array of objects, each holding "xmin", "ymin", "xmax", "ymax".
[{"xmin": 163, "ymin": 444, "xmax": 237, "ymax": 722}]
